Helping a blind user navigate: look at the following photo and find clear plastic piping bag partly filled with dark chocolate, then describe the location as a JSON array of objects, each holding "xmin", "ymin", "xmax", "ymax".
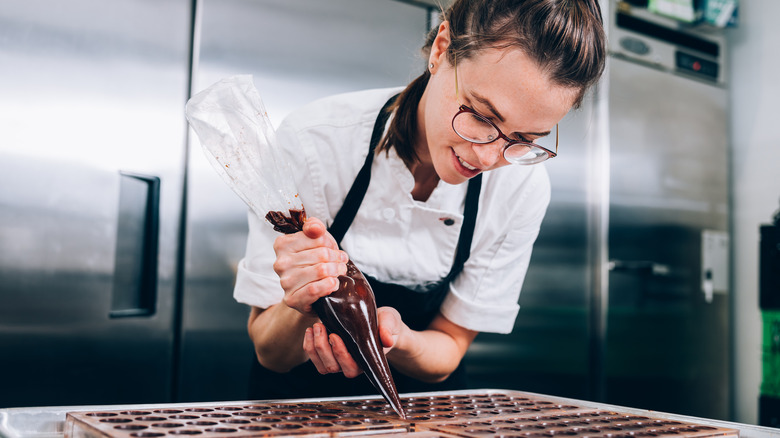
[{"xmin": 186, "ymin": 75, "xmax": 406, "ymax": 418}]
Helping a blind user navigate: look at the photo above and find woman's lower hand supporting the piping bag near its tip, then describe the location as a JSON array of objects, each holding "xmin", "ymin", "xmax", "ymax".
[{"xmin": 303, "ymin": 307, "xmax": 409, "ymax": 378}]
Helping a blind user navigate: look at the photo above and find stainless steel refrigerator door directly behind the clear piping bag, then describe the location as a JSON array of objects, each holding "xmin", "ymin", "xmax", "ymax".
[{"xmin": 178, "ymin": 0, "xmax": 428, "ymax": 401}]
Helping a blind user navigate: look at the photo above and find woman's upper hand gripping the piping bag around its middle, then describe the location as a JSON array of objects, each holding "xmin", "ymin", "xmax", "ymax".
[{"xmin": 274, "ymin": 218, "xmax": 349, "ymax": 315}]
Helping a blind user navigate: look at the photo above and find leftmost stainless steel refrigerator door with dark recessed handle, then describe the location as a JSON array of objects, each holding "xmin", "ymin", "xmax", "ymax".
[{"xmin": 0, "ymin": 0, "xmax": 191, "ymax": 407}]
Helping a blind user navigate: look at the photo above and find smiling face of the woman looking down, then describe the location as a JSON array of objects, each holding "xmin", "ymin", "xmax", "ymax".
[{"xmin": 416, "ymin": 45, "xmax": 578, "ymax": 184}]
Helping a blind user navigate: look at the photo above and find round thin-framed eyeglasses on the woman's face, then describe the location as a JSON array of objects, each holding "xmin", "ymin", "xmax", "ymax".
[{"xmin": 452, "ymin": 62, "xmax": 558, "ymax": 165}]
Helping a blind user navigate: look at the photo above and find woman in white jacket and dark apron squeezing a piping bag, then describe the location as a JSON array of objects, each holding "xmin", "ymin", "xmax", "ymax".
[{"xmin": 235, "ymin": 0, "xmax": 606, "ymax": 399}]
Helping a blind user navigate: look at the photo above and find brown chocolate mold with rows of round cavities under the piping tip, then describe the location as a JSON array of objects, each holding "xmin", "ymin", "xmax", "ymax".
[{"xmin": 65, "ymin": 390, "xmax": 738, "ymax": 438}]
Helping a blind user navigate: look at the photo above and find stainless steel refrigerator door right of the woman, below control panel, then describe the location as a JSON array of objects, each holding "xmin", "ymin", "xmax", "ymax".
[{"xmin": 605, "ymin": 58, "xmax": 729, "ymax": 419}]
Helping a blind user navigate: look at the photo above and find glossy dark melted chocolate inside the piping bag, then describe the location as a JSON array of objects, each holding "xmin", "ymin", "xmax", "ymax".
[{"xmin": 265, "ymin": 209, "xmax": 406, "ymax": 418}]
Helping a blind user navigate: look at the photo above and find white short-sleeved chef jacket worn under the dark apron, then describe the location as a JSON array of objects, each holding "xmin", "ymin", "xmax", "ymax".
[{"xmin": 234, "ymin": 88, "xmax": 550, "ymax": 333}]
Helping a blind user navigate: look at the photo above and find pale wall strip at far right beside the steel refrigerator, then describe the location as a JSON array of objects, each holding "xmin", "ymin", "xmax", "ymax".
[{"xmin": 729, "ymin": 0, "xmax": 780, "ymax": 423}]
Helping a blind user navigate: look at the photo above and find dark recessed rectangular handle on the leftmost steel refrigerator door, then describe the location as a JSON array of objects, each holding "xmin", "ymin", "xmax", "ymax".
[{"xmin": 109, "ymin": 171, "xmax": 160, "ymax": 318}]
